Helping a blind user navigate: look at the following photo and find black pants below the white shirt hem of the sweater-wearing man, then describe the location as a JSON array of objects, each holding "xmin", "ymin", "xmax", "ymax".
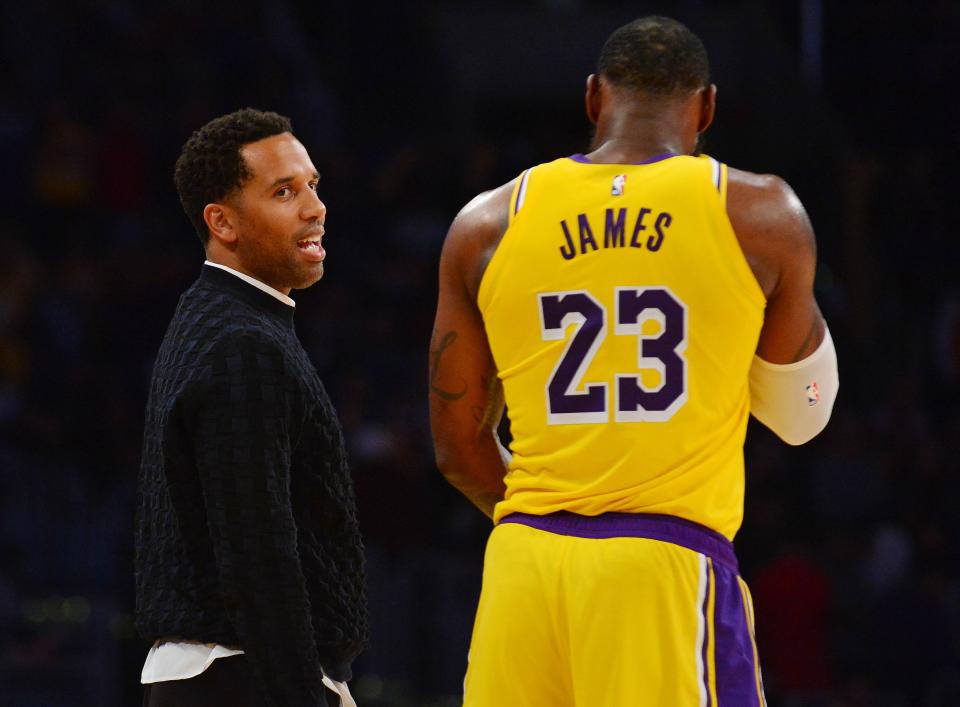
[{"xmin": 143, "ymin": 655, "xmax": 265, "ymax": 707}]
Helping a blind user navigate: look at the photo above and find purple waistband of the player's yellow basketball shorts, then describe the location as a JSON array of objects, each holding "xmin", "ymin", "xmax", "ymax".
[{"xmin": 500, "ymin": 511, "xmax": 737, "ymax": 573}]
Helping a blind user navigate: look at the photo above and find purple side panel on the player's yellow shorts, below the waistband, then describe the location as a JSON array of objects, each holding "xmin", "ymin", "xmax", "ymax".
[{"xmin": 713, "ymin": 568, "xmax": 764, "ymax": 707}]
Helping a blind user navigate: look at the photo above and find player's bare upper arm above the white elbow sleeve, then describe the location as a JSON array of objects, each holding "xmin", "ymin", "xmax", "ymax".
[{"xmin": 727, "ymin": 168, "xmax": 825, "ymax": 364}]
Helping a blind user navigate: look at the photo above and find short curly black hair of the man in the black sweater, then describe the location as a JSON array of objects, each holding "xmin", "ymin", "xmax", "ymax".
[{"xmin": 173, "ymin": 108, "xmax": 292, "ymax": 247}]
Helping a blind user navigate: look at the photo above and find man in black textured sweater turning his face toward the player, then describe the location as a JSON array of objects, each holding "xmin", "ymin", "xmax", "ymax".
[{"xmin": 136, "ymin": 109, "xmax": 368, "ymax": 707}]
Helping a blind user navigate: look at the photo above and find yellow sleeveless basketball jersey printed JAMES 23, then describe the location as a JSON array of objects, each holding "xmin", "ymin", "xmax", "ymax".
[{"xmin": 478, "ymin": 155, "xmax": 766, "ymax": 539}]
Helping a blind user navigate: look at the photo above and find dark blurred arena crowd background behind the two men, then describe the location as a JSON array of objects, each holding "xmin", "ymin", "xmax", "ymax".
[{"xmin": 0, "ymin": 0, "xmax": 960, "ymax": 707}]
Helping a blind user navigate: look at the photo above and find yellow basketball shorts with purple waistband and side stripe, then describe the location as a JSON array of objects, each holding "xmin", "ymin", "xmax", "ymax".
[{"xmin": 464, "ymin": 512, "xmax": 766, "ymax": 707}]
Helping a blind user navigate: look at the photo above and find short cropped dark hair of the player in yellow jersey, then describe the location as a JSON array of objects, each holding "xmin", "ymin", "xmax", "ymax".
[{"xmin": 597, "ymin": 16, "xmax": 710, "ymax": 97}]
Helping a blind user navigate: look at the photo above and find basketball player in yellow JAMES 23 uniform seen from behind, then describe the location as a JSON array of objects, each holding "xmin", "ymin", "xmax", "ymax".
[{"xmin": 430, "ymin": 17, "xmax": 838, "ymax": 707}]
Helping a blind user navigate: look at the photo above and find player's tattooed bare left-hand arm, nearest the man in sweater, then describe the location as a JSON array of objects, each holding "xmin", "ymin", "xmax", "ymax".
[{"xmin": 430, "ymin": 182, "xmax": 513, "ymax": 517}]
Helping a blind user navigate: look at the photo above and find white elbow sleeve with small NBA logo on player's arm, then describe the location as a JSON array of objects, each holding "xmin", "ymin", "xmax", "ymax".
[{"xmin": 750, "ymin": 329, "xmax": 840, "ymax": 444}]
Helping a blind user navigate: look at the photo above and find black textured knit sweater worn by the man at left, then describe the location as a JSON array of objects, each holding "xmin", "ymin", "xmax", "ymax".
[{"xmin": 135, "ymin": 266, "xmax": 368, "ymax": 706}]
